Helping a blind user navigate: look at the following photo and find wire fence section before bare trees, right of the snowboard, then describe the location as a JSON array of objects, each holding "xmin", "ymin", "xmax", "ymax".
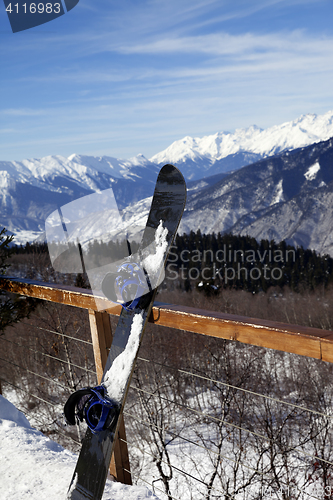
[{"xmin": 124, "ymin": 357, "xmax": 333, "ymax": 500}]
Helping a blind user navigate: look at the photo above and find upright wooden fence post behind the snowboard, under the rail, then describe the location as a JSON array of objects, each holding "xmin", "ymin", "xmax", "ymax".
[{"xmin": 89, "ymin": 309, "xmax": 132, "ymax": 484}]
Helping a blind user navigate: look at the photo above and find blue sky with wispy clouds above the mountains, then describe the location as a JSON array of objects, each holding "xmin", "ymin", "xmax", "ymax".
[{"xmin": 0, "ymin": 0, "xmax": 333, "ymax": 160}]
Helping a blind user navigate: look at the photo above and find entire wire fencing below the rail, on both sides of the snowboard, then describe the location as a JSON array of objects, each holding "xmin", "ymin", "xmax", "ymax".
[{"xmin": 0, "ymin": 298, "xmax": 333, "ymax": 500}]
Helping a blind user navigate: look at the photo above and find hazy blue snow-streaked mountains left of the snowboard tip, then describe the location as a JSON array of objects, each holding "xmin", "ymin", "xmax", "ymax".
[{"xmin": 0, "ymin": 155, "xmax": 159, "ymax": 243}]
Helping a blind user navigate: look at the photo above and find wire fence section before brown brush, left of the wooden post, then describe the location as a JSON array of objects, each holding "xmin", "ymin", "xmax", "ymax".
[{"xmin": 0, "ymin": 304, "xmax": 96, "ymax": 452}]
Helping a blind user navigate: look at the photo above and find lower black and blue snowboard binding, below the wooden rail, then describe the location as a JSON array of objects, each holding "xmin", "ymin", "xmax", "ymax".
[{"xmin": 64, "ymin": 385, "xmax": 119, "ymax": 434}]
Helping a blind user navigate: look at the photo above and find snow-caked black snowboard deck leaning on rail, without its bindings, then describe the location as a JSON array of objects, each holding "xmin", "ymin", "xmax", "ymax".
[{"xmin": 68, "ymin": 165, "xmax": 186, "ymax": 500}]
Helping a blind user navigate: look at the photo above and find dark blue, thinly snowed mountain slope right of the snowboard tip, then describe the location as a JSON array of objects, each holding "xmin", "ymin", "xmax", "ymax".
[{"xmin": 180, "ymin": 139, "xmax": 333, "ymax": 255}]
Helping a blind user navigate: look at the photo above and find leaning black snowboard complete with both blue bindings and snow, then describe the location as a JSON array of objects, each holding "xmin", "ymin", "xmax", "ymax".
[{"xmin": 65, "ymin": 165, "xmax": 186, "ymax": 500}]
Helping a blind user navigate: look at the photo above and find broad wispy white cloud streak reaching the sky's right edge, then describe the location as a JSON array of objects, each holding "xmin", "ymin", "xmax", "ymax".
[{"xmin": 12, "ymin": 30, "xmax": 333, "ymax": 91}]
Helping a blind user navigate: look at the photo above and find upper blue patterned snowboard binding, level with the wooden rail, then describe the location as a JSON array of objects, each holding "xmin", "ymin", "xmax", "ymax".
[{"xmin": 102, "ymin": 262, "xmax": 150, "ymax": 311}]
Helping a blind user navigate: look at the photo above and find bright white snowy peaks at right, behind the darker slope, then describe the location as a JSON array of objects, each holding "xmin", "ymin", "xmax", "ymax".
[{"xmin": 150, "ymin": 111, "xmax": 333, "ymax": 180}]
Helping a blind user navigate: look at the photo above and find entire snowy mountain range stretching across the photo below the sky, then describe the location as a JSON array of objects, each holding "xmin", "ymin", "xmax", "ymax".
[{"xmin": 0, "ymin": 111, "xmax": 333, "ymax": 255}]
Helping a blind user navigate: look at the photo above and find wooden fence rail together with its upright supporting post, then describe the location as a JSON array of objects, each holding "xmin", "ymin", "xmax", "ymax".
[{"xmin": 0, "ymin": 276, "xmax": 333, "ymax": 484}]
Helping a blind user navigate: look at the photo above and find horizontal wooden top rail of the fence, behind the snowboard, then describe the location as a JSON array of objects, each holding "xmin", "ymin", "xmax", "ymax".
[{"xmin": 0, "ymin": 277, "xmax": 333, "ymax": 362}]
